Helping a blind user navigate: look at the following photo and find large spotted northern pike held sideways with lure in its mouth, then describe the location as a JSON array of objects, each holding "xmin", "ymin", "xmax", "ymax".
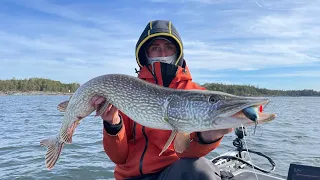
[{"xmin": 40, "ymin": 74, "xmax": 276, "ymax": 169}]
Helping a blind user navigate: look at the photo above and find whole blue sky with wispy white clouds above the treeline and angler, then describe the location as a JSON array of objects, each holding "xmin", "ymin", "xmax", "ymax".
[{"xmin": 0, "ymin": 0, "xmax": 320, "ymax": 91}]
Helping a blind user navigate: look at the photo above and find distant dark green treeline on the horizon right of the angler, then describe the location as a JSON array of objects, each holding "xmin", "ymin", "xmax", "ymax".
[{"xmin": 202, "ymin": 83, "xmax": 320, "ymax": 96}]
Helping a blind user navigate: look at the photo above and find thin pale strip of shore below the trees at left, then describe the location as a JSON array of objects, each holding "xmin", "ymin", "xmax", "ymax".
[{"xmin": 0, "ymin": 91, "xmax": 73, "ymax": 96}]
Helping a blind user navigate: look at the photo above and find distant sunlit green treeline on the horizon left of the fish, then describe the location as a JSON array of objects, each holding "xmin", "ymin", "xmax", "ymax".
[{"xmin": 0, "ymin": 78, "xmax": 80, "ymax": 93}]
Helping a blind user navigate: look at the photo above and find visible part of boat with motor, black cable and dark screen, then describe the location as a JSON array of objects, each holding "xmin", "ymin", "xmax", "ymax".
[{"xmin": 211, "ymin": 127, "xmax": 320, "ymax": 180}]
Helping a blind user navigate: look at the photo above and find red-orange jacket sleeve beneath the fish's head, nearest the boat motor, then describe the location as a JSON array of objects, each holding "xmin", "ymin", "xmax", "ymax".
[{"xmin": 177, "ymin": 133, "xmax": 222, "ymax": 158}]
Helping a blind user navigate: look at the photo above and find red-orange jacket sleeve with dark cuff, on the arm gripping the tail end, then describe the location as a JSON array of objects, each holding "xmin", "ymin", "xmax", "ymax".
[{"xmin": 103, "ymin": 113, "xmax": 130, "ymax": 164}]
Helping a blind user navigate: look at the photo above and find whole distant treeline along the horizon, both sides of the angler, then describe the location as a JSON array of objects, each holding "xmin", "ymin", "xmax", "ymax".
[{"xmin": 0, "ymin": 78, "xmax": 320, "ymax": 96}]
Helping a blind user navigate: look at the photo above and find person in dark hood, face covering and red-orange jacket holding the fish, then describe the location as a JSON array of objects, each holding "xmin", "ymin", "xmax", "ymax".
[{"xmin": 91, "ymin": 20, "xmax": 232, "ymax": 180}]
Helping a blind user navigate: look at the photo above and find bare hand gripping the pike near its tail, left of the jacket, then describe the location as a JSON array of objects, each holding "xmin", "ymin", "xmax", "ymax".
[{"xmin": 90, "ymin": 96, "xmax": 120, "ymax": 125}]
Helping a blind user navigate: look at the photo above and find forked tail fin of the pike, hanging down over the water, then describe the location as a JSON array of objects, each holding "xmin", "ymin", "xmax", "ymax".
[{"xmin": 40, "ymin": 137, "xmax": 64, "ymax": 170}]
